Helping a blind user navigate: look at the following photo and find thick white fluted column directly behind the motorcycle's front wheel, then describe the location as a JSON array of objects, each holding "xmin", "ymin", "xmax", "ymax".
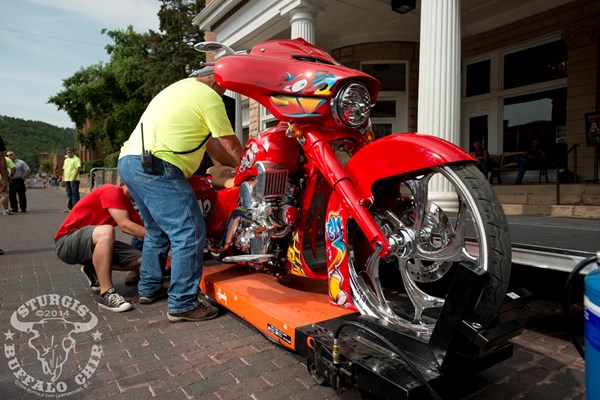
[{"xmin": 417, "ymin": 0, "xmax": 461, "ymax": 208}]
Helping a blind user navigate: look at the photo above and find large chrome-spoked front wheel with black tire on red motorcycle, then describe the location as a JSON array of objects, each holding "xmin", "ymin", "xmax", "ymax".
[{"xmin": 348, "ymin": 164, "xmax": 511, "ymax": 336}]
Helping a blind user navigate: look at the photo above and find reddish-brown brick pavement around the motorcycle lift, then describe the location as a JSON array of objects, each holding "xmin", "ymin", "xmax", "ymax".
[{"xmin": 0, "ymin": 189, "xmax": 585, "ymax": 400}]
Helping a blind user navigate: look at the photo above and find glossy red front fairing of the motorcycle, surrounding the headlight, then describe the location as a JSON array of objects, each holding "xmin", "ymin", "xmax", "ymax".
[{"xmin": 215, "ymin": 38, "xmax": 380, "ymax": 128}]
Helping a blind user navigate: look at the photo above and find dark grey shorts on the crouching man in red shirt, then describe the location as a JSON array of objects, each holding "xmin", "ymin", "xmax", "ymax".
[{"xmin": 55, "ymin": 225, "xmax": 142, "ymax": 268}]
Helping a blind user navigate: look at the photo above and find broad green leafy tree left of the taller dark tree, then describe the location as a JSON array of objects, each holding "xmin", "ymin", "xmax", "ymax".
[{"xmin": 49, "ymin": 26, "xmax": 151, "ymax": 153}]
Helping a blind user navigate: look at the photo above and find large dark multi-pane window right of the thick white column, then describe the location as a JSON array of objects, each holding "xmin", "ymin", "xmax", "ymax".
[{"xmin": 462, "ymin": 32, "xmax": 568, "ymax": 162}]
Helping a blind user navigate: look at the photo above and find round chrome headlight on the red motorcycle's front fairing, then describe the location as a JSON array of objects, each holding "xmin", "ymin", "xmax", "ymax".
[{"xmin": 331, "ymin": 82, "xmax": 371, "ymax": 128}]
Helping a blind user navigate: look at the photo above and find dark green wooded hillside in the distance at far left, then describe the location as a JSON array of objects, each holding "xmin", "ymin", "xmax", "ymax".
[{"xmin": 0, "ymin": 115, "xmax": 77, "ymax": 171}]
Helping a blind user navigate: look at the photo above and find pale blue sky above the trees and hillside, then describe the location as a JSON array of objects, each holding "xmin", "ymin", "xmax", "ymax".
[{"xmin": 0, "ymin": 0, "xmax": 161, "ymax": 128}]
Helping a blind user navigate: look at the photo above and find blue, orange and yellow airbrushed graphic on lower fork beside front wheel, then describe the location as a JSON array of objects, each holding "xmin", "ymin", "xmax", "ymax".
[{"xmin": 325, "ymin": 211, "xmax": 351, "ymax": 307}]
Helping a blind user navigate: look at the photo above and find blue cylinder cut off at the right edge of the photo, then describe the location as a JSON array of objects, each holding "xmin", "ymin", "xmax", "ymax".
[{"xmin": 583, "ymin": 269, "xmax": 600, "ymax": 400}]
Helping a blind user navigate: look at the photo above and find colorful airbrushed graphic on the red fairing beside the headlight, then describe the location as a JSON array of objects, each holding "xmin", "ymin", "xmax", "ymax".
[{"xmin": 271, "ymin": 71, "xmax": 339, "ymax": 117}]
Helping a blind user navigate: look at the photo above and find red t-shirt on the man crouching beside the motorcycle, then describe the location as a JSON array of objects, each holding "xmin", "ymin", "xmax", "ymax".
[{"xmin": 54, "ymin": 184, "xmax": 143, "ymax": 240}]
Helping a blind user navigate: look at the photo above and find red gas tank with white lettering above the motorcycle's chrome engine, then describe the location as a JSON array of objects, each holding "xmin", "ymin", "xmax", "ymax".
[{"xmin": 234, "ymin": 123, "xmax": 300, "ymax": 186}]
